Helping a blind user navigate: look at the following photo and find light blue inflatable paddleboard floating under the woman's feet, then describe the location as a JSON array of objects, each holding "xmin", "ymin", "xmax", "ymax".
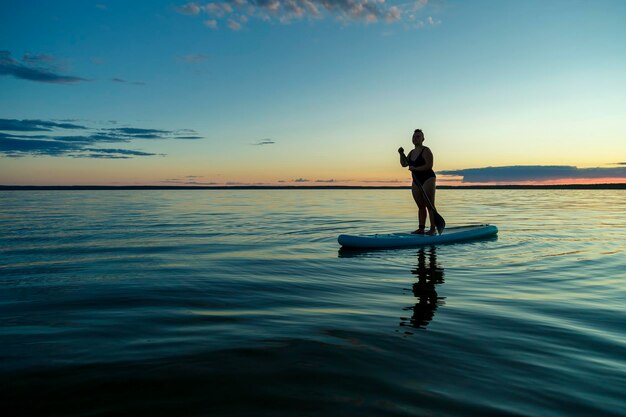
[{"xmin": 337, "ymin": 224, "xmax": 498, "ymax": 249}]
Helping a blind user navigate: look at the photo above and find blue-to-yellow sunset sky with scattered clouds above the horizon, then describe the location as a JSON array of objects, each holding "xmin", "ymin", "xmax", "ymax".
[{"xmin": 0, "ymin": 0, "xmax": 626, "ymax": 185}]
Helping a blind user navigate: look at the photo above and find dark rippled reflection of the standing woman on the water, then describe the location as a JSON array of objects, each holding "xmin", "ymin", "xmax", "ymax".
[{"xmin": 400, "ymin": 246, "xmax": 445, "ymax": 334}]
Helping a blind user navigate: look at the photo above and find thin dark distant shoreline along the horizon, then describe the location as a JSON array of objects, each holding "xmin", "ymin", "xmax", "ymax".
[{"xmin": 0, "ymin": 184, "xmax": 626, "ymax": 191}]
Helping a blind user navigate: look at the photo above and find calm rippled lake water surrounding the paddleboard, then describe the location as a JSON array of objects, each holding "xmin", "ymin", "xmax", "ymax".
[{"xmin": 0, "ymin": 190, "xmax": 626, "ymax": 417}]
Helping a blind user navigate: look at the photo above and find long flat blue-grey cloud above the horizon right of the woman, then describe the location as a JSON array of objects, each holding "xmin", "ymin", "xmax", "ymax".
[{"xmin": 437, "ymin": 165, "xmax": 626, "ymax": 183}]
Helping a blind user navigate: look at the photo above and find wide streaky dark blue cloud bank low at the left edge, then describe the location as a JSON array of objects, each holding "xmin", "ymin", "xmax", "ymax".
[{"xmin": 0, "ymin": 119, "xmax": 202, "ymax": 159}]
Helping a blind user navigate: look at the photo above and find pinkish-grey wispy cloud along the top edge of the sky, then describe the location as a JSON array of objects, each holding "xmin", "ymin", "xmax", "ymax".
[{"xmin": 176, "ymin": 0, "xmax": 441, "ymax": 30}]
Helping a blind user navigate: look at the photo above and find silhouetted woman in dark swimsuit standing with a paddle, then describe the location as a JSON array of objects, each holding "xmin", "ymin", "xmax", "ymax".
[{"xmin": 398, "ymin": 129, "xmax": 436, "ymax": 235}]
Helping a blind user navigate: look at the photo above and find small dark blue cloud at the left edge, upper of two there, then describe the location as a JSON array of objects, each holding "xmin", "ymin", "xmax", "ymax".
[{"xmin": 0, "ymin": 51, "xmax": 89, "ymax": 84}]
